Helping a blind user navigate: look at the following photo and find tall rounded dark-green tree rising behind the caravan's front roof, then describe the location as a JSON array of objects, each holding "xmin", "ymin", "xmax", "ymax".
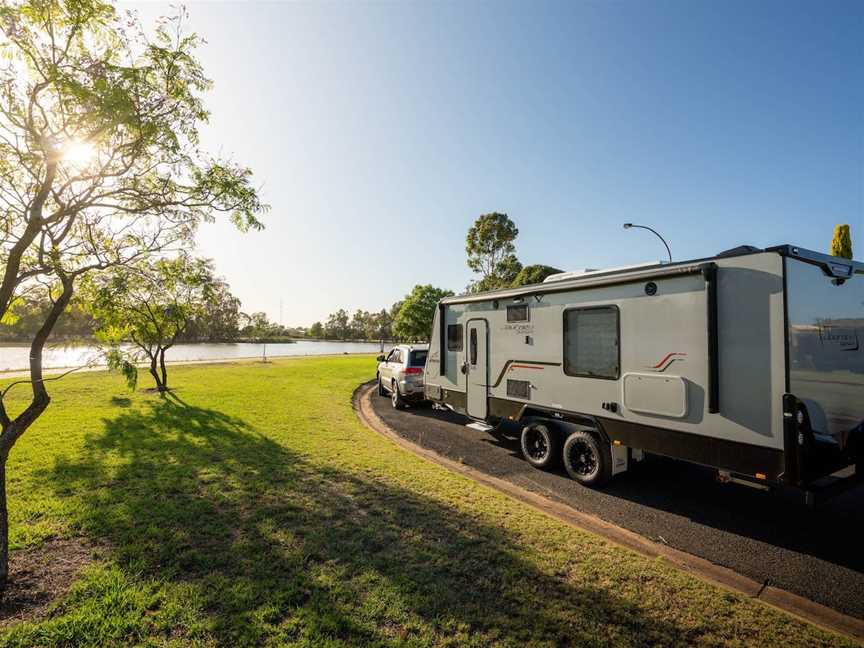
[{"xmin": 465, "ymin": 212, "xmax": 522, "ymax": 292}]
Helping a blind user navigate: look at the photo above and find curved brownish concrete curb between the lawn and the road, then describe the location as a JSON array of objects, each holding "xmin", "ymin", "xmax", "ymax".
[{"xmin": 352, "ymin": 383, "xmax": 864, "ymax": 646}]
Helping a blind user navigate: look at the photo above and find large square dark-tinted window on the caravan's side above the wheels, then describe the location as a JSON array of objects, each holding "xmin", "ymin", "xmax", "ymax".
[{"xmin": 564, "ymin": 306, "xmax": 620, "ymax": 380}]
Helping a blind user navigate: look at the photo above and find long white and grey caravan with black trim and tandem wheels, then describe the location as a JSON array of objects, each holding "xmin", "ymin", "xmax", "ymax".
[{"xmin": 426, "ymin": 245, "xmax": 864, "ymax": 499}]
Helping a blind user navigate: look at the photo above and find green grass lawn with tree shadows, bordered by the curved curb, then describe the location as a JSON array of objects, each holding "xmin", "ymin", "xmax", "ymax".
[{"xmin": 0, "ymin": 357, "xmax": 844, "ymax": 646}]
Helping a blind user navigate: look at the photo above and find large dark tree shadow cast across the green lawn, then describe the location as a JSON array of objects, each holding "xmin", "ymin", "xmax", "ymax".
[{"xmin": 32, "ymin": 395, "xmax": 768, "ymax": 645}]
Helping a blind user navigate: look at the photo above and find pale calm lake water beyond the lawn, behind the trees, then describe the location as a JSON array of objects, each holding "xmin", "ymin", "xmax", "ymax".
[{"xmin": 0, "ymin": 340, "xmax": 390, "ymax": 371}]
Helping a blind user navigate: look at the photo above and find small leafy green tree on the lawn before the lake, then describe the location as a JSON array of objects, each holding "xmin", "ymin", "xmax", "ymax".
[{"xmin": 82, "ymin": 256, "xmax": 216, "ymax": 392}]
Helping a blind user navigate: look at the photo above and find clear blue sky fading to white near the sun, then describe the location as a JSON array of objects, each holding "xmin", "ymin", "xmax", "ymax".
[{"xmin": 121, "ymin": 0, "xmax": 864, "ymax": 324}]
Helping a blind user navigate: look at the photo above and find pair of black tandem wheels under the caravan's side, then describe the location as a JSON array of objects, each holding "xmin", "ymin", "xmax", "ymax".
[{"xmin": 520, "ymin": 423, "xmax": 612, "ymax": 486}]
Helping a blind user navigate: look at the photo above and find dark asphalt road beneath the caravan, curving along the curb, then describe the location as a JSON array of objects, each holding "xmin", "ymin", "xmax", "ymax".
[{"xmin": 372, "ymin": 395, "xmax": 864, "ymax": 619}]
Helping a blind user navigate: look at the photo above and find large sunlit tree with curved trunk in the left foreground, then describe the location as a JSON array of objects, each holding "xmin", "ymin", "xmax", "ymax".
[{"xmin": 0, "ymin": 0, "xmax": 266, "ymax": 590}]
